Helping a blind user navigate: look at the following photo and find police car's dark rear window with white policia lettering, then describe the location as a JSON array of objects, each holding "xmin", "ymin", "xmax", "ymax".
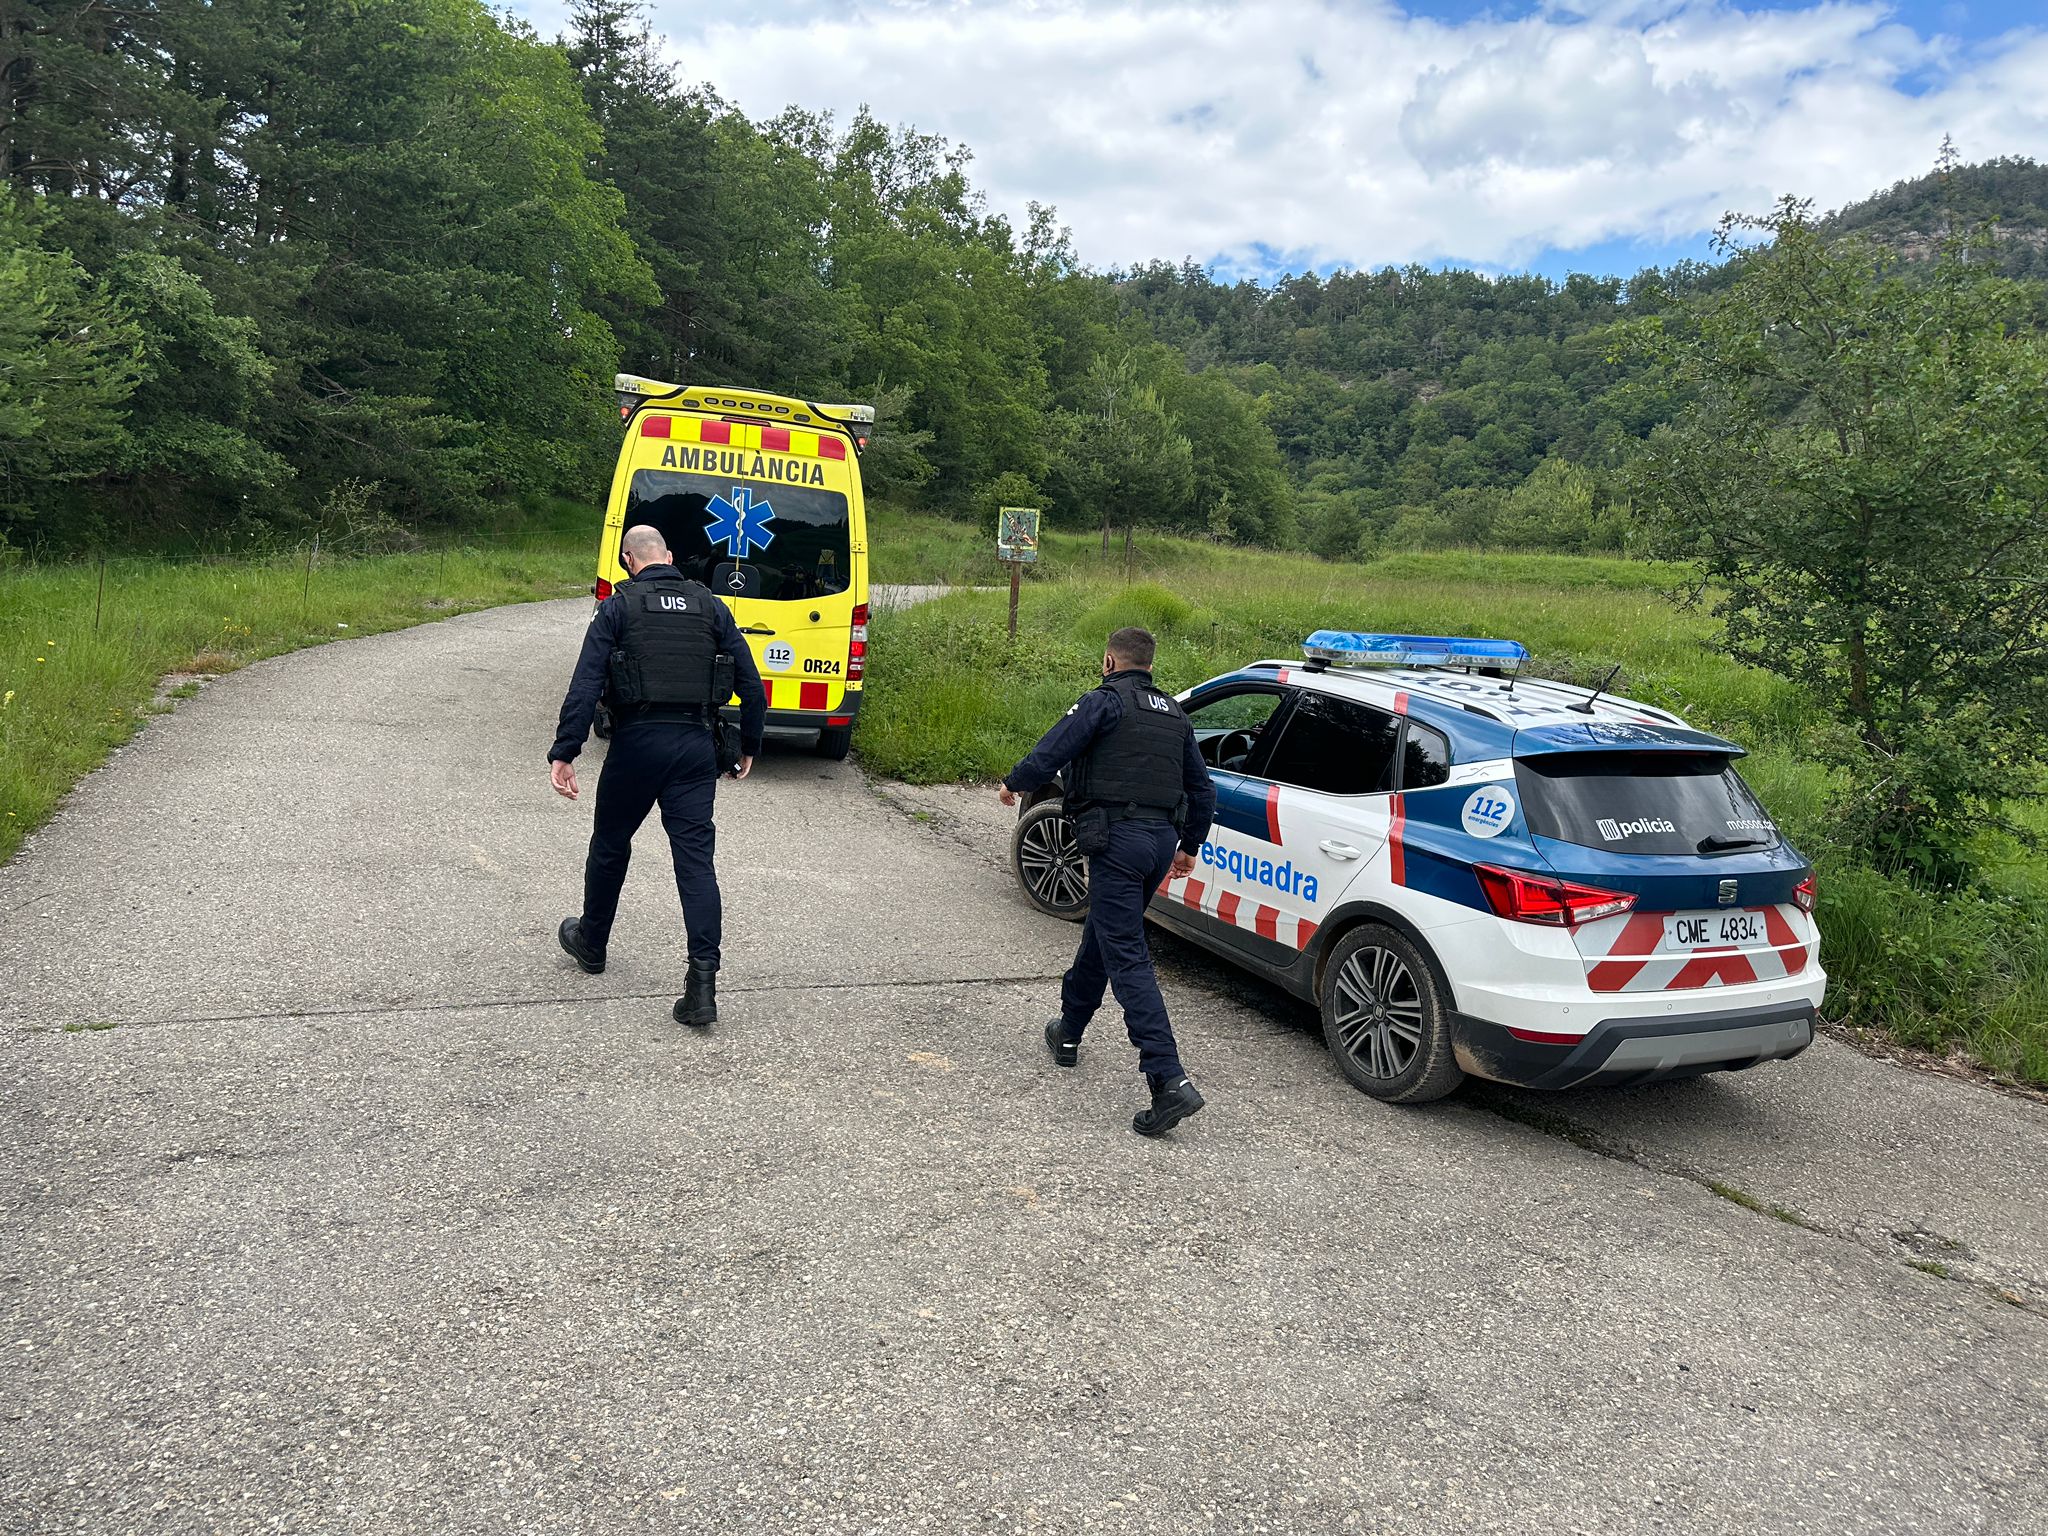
[{"xmin": 1516, "ymin": 752, "xmax": 1778, "ymax": 856}]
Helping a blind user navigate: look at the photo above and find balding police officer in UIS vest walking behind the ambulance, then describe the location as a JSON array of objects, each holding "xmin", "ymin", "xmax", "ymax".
[{"xmin": 547, "ymin": 524, "xmax": 768, "ymax": 1026}]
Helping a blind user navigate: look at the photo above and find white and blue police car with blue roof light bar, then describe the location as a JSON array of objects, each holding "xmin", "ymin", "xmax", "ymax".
[{"xmin": 1012, "ymin": 631, "xmax": 1827, "ymax": 1104}]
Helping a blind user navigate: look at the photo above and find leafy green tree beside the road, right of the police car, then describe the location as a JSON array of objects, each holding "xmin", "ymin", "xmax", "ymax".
[{"xmin": 1636, "ymin": 201, "xmax": 2048, "ymax": 883}]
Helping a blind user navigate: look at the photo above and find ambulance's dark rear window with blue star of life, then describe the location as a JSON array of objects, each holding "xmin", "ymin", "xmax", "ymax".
[{"xmin": 627, "ymin": 469, "xmax": 852, "ymax": 602}]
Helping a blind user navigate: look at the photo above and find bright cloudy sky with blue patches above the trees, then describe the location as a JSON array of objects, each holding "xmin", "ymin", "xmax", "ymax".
[{"xmin": 499, "ymin": 0, "xmax": 2048, "ymax": 276}]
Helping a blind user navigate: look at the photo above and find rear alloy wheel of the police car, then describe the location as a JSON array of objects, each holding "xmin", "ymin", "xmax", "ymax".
[{"xmin": 1321, "ymin": 924, "xmax": 1464, "ymax": 1104}]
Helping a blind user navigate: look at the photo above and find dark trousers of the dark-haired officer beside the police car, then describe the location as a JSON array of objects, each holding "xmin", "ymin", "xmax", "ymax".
[{"xmin": 1059, "ymin": 821, "xmax": 1180, "ymax": 1077}]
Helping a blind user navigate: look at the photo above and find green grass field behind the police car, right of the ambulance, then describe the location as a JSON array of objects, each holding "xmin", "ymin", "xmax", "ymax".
[{"xmin": 856, "ymin": 514, "xmax": 2048, "ymax": 1083}]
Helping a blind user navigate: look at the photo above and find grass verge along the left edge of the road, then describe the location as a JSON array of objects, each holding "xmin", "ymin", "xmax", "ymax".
[{"xmin": 0, "ymin": 508, "xmax": 594, "ymax": 862}]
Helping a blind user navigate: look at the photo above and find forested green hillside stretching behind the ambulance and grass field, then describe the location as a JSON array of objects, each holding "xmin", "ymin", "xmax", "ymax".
[{"xmin": 0, "ymin": 0, "xmax": 2048, "ymax": 557}]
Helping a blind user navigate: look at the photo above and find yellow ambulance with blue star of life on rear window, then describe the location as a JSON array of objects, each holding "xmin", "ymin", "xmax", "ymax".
[{"xmin": 594, "ymin": 373, "xmax": 874, "ymax": 758}]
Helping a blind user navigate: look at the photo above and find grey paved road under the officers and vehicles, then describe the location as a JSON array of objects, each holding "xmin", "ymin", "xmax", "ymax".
[{"xmin": 0, "ymin": 602, "xmax": 2048, "ymax": 1534}]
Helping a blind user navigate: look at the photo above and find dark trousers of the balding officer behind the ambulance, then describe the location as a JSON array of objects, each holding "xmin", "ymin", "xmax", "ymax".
[{"xmin": 584, "ymin": 721, "xmax": 723, "ymax": 969}]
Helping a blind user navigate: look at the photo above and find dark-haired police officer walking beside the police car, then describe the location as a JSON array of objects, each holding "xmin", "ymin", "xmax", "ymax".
[{"xmin": 999, "ymin": 629, "xmax": 1217, "ymax": 1137}]
